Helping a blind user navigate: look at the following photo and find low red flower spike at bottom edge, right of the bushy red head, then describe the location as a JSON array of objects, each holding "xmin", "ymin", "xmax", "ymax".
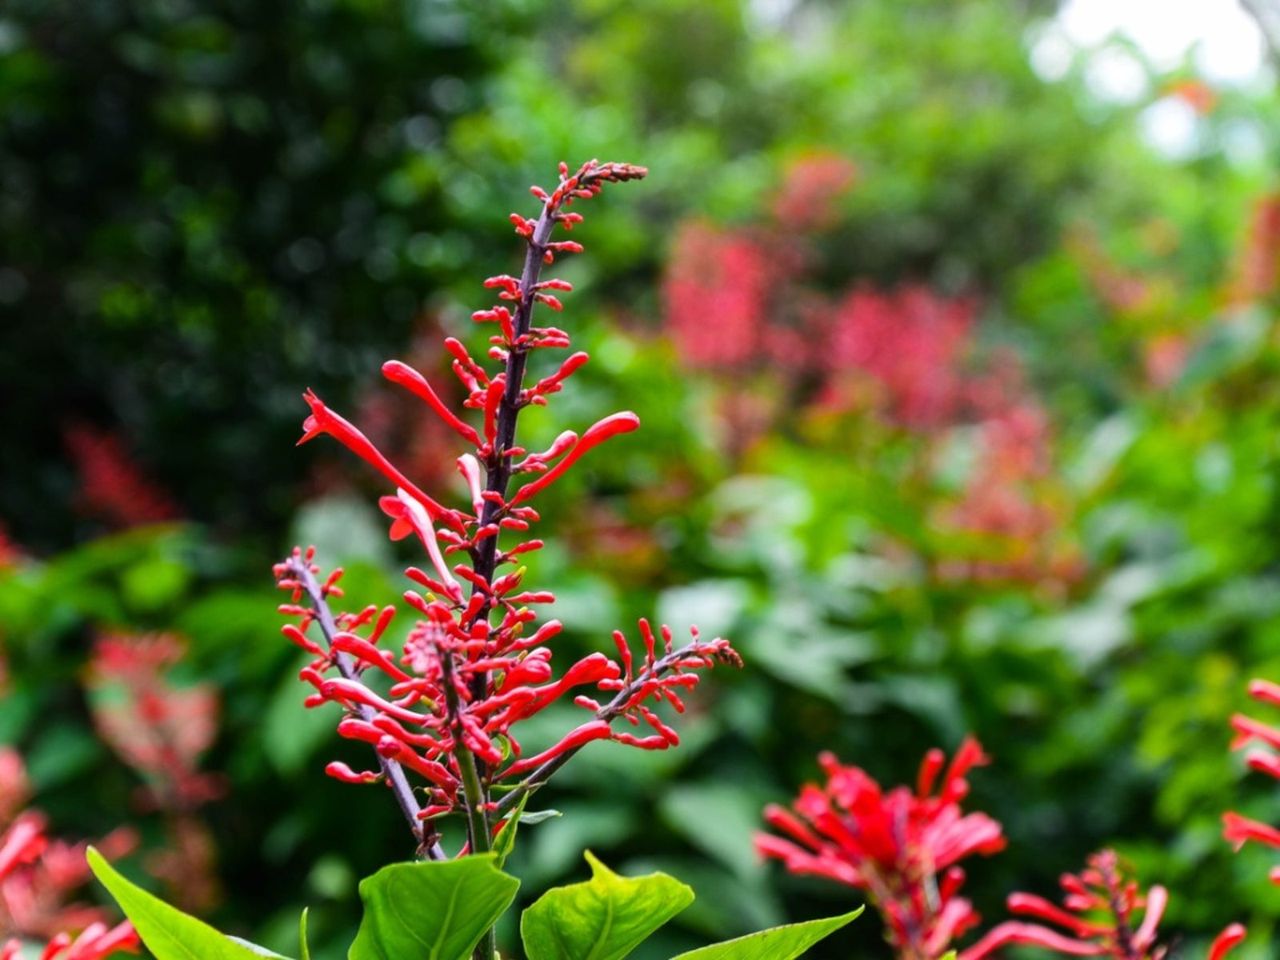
[{"xmin": 960, "ymin": 850, "xmax": 1245, "ymax": 960}]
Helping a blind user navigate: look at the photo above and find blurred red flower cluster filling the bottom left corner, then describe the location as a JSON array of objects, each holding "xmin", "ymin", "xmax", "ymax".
[{"xmin": 0, "ymin": 749, "xmax": 138, "ymax": 960}]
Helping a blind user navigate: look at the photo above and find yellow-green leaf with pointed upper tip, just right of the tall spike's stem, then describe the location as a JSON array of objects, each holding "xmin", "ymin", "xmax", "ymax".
[{"xmin": 520, "ymin": 851, "xmax": 694, "ymax": 960}]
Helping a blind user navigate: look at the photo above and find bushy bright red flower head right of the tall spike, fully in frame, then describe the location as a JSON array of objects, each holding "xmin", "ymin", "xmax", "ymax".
[{"xmin": 755, "ymin": 737, "xmax": 1005, "ymax": 960}]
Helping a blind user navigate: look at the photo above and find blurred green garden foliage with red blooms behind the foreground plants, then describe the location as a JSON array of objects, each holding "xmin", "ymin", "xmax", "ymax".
[{"xmin": 0, "ymin": 0, "xmax": 1280, "ymax": 960}]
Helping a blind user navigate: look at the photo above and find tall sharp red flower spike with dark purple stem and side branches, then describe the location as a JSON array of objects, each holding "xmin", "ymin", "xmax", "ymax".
[{"xmin": 275, "ymin": 160, "xmax": 740, "ymax": 859}]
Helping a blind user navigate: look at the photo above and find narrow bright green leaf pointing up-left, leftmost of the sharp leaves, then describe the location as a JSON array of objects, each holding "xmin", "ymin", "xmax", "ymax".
[{"xmin": 87, "ymin": 847, "xmax": 293, "ymax": 960}]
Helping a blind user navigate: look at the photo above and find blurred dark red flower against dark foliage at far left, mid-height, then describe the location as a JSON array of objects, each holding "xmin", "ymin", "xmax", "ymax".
[{"xmin": 64, "ymin": 424, "xmax": 180, "ymax": 527}]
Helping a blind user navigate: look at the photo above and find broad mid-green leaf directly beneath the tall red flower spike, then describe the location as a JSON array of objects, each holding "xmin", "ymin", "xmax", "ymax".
[{"xmin": 347, "ymin": 854, "xmax": 520, "ymax": 960}]
